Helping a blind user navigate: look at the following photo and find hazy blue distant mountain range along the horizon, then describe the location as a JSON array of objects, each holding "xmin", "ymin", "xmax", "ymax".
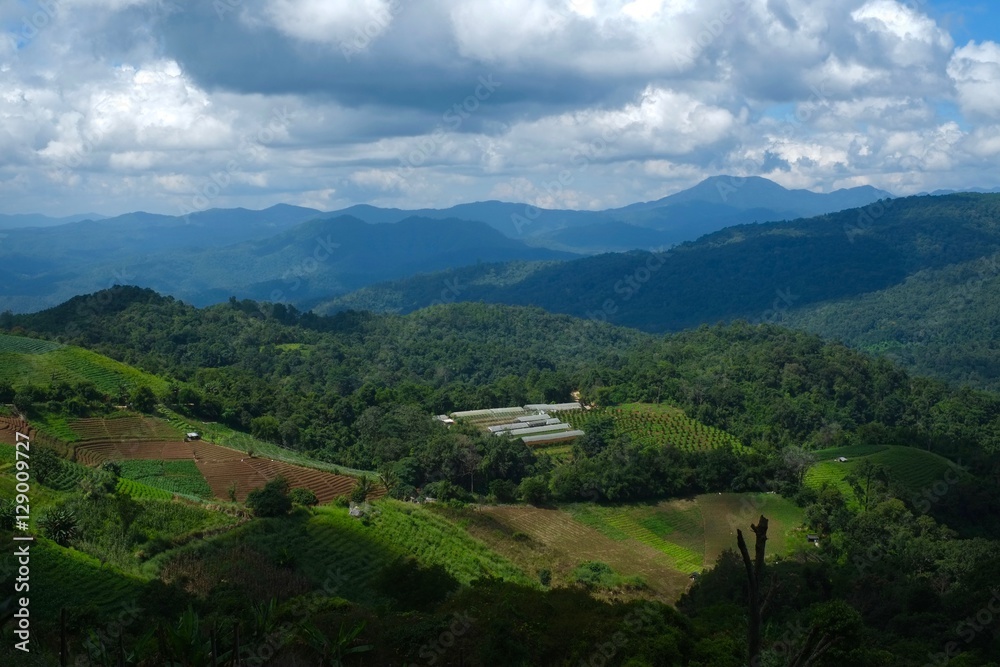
[{"xmin": 0, "ymin": 177, "xmax": 888, "ymax": 312}]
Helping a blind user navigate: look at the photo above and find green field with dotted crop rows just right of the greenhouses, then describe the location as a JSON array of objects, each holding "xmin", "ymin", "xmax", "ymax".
[{"xmin": 561, "ymin": 403, "xmax": 745, "ymax": 452}]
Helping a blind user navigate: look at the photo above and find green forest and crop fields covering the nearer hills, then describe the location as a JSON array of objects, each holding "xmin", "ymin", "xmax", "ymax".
[{"xmin": 0, "ymin": 288, "xmax": 1000, "ymax": 667}]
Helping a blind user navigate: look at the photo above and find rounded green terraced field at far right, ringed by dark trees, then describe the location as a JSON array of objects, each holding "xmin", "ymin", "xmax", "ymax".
[{"xmin": 805, "ymin": 445, "xmax": 966, "ymax": 498}]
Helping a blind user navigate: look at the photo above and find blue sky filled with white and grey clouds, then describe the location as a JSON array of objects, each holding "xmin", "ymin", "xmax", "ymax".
[{"xmin": 0, "ymin": 0, "xmax": 1000, "ymax": 215}]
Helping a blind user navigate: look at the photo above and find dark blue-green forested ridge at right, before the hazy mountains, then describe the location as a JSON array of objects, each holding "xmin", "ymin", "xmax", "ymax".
[{"xmin": 316, "ymin": 194, "xmax": 1000, "ymax": 389}]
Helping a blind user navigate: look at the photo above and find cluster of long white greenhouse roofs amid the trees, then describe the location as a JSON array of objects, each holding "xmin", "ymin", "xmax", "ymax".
[{"xmin": 438, "ymin": 402, "xmax": 584, "ymax": 445}]
